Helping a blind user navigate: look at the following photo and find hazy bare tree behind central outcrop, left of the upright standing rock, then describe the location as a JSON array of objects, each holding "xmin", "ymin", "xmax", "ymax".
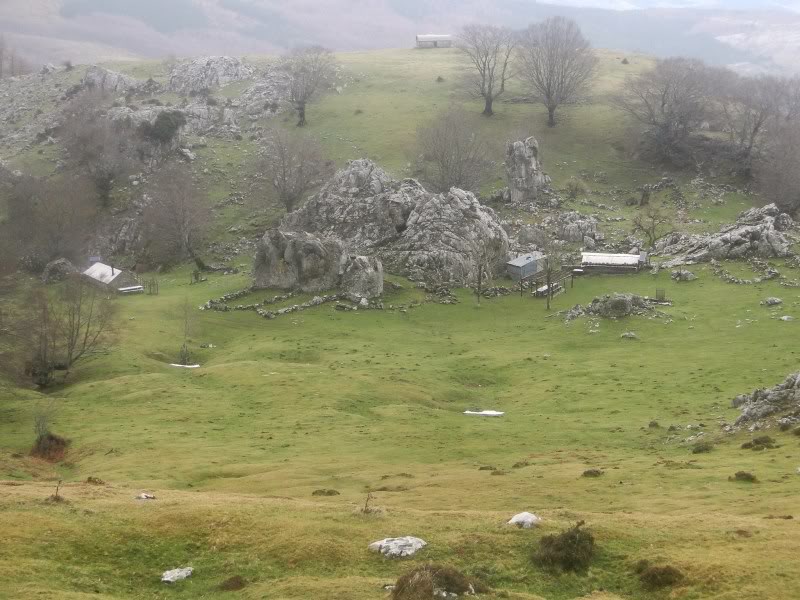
[{"xmin": 417, "ymin": 107, "xmax": 489, "ymax": 192}]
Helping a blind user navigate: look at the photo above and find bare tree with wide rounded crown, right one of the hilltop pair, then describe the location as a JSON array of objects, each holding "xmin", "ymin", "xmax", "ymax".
[{"xmin": 517, "ymin": 17, "xmax": 597, "ymax": 127}]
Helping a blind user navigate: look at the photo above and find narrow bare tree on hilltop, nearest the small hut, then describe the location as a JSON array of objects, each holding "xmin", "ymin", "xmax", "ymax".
[{"xmin": 458, "ymin": 25, "xmax": 516, "ymax": 117}]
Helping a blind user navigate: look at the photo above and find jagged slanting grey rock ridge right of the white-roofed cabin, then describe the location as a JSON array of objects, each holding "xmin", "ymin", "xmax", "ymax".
[{"xmin": 655, "ymin": 204, "xmax": 794, "ymax": 268}]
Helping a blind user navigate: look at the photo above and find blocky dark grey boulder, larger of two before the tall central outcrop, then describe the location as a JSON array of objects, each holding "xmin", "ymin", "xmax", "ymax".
[{"xmin": 253, "ymin": 229, "xmax": 345, "ymax": 292}]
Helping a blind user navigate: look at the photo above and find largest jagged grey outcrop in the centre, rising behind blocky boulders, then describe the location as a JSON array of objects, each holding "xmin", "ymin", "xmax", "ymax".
[{"xmin": 281, "ymin": 159, "xmax": 509, "ymax": 283}]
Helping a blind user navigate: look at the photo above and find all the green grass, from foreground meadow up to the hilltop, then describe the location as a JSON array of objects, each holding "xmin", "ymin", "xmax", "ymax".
[{"xmin": 0, "ymin": 50, "xmax": 800, "ymax": 600}]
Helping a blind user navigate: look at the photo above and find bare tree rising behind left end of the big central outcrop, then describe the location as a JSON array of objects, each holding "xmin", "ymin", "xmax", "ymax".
[{"xmin": 261, "ymin": 128, "xmax": 334, "ymax": 212}]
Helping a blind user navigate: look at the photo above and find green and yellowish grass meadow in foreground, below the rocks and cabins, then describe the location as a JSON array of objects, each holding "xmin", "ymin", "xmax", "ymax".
[{"xmin": 0, "ymin": 269, "xmax": 800, "ymax": 598}]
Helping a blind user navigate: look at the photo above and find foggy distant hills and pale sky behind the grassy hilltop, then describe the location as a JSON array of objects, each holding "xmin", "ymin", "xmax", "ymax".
[{"xmin": 0, "ymin": 0, "xmax": 800, "ymax": 71}]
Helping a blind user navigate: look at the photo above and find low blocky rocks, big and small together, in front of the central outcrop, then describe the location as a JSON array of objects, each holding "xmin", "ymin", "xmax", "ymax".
[{"xmin": 253, "ymin": 229, "xmax": 383, "ymax": 301}]
